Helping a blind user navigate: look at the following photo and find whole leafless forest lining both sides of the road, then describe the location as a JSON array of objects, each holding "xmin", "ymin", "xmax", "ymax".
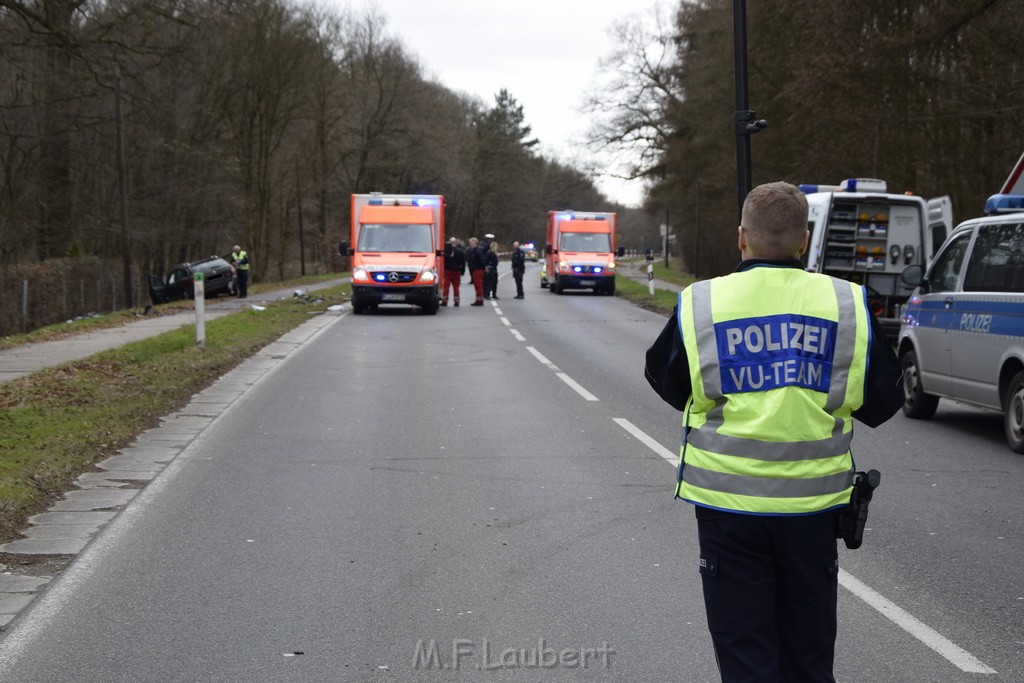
[{"xmin": 0, "ymin": 0, "xmax": 1024, "ymax": 334}]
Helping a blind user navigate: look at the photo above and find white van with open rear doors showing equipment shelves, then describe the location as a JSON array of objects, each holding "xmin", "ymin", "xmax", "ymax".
[{"xmin": 800, "ymin": 178, "xmax": 952, "ymax": 343}]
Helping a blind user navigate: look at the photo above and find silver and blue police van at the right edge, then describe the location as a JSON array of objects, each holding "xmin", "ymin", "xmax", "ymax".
[{"xmin": 898, "ymin": 195, "xmax": 1024, "ymax": 453}]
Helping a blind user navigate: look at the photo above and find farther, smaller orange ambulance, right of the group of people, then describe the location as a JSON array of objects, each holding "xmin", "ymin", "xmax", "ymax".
[{"xmin": 541, "ymin": 211, "xmax": 622, "ymax": 294}]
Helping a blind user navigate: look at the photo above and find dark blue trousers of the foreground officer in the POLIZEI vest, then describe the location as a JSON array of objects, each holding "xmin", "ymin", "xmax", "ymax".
[{"xmin": 696, "ymin": 507, "xmax": 839, "ymax": 683}]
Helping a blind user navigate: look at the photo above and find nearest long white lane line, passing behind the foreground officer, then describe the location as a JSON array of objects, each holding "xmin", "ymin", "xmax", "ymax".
[{"xmin": 612, "ymin": 418, "xmax": 998, "ymax": 674}]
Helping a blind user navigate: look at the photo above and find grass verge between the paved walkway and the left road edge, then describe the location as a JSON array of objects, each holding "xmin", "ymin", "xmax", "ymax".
[{"xmin": 0, "ymin": 285, "xmax": 351, "ymax": 542}]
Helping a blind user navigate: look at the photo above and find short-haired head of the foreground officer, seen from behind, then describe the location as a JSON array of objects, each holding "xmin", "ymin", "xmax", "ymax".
[{"xmin": 740, "ymin": 182, "xmax": 807, "ymax": 259}]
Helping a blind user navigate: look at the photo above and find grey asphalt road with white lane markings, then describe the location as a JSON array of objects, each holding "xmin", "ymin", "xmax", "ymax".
[{"xmin": 0, "ymin": 264, "xmax": 1024, "ymax": 682}]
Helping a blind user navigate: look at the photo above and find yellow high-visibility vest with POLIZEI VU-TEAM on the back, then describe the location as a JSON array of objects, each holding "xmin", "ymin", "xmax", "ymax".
[{"xmin": 677, "ymin": 266, "xmax": 868, "ymax": 514}]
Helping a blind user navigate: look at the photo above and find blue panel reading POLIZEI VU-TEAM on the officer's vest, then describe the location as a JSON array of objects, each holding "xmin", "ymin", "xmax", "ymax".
[{"xmin": 715, "ymin": 313, "xmax": 839, "ymax": 394}]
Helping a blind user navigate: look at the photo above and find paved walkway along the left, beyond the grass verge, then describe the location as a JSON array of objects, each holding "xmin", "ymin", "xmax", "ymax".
[{"xmin": 0, "ymin": 278, "xmax": 348, "ymax": 383}]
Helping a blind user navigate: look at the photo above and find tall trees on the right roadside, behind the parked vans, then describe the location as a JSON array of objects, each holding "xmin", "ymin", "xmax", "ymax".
[{"xmin": 590, "ymin": 0, "xmax": 1024, "ymax": 276}]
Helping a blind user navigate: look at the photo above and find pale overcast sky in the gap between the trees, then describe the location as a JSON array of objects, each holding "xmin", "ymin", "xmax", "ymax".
[{"xmin": 344, "ymin": 0, "xmax": 656, "ymax": 206}]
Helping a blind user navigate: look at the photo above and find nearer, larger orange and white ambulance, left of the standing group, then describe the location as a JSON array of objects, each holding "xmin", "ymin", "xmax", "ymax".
[{"xmin": 338, "ymin": 193, "xmax": 444, "ymax": 314}]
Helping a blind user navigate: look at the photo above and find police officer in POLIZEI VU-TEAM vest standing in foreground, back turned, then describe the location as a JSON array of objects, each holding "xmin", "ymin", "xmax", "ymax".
[{"xmin": 644, "ymin": 182, "xmax": 903, "ymax": 683}]
